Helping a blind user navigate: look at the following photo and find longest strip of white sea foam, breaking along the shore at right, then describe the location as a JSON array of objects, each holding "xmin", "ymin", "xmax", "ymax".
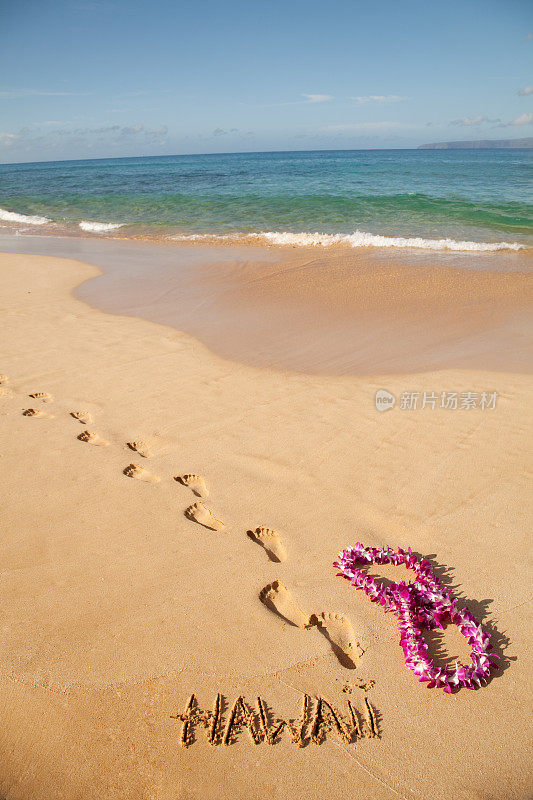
[{"xmin": 171, "ymin": 231, "xmax": 524, "ymax": 252}]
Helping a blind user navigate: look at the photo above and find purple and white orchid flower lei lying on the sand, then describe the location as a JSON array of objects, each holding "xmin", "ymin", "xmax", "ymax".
[{"xmin": 334, "ymin": 542, "xmax": 498, "ymax": 693}]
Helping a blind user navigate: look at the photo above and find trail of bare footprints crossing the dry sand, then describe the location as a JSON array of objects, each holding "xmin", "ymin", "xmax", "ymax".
[{"xmin": 7, "ymin": 375, "xmax": 363, "ymax": 669}]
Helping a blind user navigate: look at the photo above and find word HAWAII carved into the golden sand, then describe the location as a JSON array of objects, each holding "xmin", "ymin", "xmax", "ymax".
[{"xmin": 171, "ymin": 693, "xmax": 379, "ymax": 747}]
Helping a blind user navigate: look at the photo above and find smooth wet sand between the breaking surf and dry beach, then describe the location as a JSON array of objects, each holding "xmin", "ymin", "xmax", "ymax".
[{"xmin": 0, "ymin": 237, "xmax": 533, "ymax": 376}]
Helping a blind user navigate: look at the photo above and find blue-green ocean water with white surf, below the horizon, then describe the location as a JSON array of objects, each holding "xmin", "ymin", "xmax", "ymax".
[{"xmin": 0, "ymin": 150, "xmax": 533, "ymax": 251}]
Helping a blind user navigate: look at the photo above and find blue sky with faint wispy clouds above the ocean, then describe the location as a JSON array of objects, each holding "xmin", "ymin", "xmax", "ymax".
[{"xmin": 0, "ymin": 0, "xmax": 533, "ymax": 162}]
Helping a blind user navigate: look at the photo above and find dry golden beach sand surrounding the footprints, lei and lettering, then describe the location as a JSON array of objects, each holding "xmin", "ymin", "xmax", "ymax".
[{"xmin": 0, "ymin": 247, "xmax": 531, "ymax": 800}]
